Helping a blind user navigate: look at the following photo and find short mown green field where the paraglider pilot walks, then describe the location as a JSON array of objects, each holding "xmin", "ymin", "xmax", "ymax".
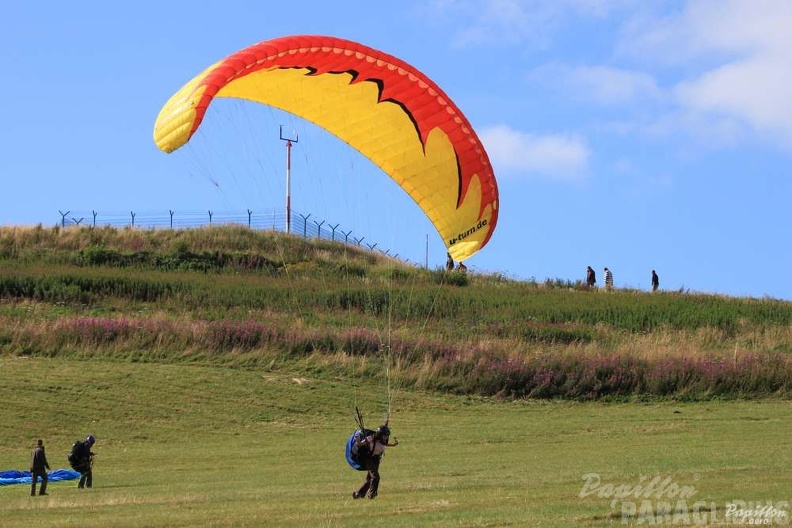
[{"xmin": 0, "ymin": 357, "xmax": 792, "ymax": 527}]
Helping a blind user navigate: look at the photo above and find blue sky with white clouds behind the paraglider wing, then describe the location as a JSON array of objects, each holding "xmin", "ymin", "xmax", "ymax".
[{"xmin": 0, "ymin": 0, "xmax": 792, "ymax": 300}]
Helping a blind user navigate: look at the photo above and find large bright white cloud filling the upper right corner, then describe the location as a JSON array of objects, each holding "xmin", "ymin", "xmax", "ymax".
[{"xmin": 619, "ymin": 0, "xmax": 792, "ymax": 147}]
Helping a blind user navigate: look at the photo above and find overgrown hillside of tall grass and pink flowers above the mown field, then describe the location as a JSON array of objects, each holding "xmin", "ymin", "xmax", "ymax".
[{"xmin": 0, "ymin": 226, "xmax": 792, "ymax": 400}]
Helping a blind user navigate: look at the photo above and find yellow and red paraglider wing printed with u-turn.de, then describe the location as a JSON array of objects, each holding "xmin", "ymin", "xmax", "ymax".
[{"xmin": 154, "ymin": 36, "xmax": 498, "ymax": 260}]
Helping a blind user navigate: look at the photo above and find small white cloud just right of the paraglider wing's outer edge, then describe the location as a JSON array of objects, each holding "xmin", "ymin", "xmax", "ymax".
[{"xmin": 479, "ymin": 125, "xmax": 590, "ymax": 182}]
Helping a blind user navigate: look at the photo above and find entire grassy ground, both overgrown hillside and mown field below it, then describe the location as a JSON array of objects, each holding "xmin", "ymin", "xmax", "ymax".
[{"xmin": 0, "ymin": 227, "xmax": 792, "ymax": 528}]
